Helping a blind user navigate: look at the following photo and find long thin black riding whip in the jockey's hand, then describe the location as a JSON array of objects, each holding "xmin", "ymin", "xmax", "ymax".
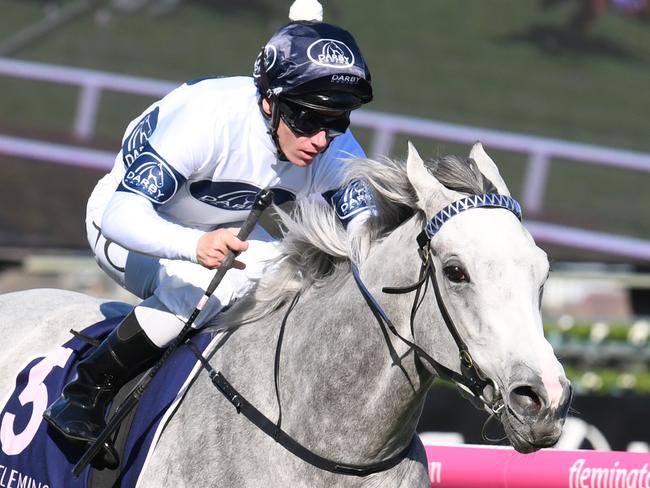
[{"xmin": 72, "ymin": 189, "xmax": 273, "ymax": 478}]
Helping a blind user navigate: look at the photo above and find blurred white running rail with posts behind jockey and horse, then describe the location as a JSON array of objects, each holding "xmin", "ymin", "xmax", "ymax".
[{"xmin": 0, "ymin": 58, "xmax": 650, "ymax": 261}]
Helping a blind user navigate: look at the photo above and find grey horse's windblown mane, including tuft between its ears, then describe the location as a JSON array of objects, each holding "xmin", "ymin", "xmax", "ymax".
[{"xmin": 216, "ymin": 152, "xmax": 497, "ymax": 327}]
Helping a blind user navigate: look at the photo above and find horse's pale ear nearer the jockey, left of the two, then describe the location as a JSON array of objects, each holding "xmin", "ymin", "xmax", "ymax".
[{"xmin": 406, "ymin": 141, "xmax": 457, "ymax": 214}]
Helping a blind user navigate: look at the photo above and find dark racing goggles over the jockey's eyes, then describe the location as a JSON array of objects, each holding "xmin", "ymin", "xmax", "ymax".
[{"xmin": 277, "ymin": 100, "xmax": 350, "ymax": 139}]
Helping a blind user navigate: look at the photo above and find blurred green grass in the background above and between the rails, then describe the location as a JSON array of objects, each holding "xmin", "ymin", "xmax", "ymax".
[{"xmin": 0, "ymin": 0, "xmax": 650, "ymax": 242}]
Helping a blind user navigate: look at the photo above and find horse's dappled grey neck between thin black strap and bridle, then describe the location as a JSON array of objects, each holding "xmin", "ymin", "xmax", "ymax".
[{"xmin": 282, "ymin": 219, "xmax": 430, "ymax": 463}]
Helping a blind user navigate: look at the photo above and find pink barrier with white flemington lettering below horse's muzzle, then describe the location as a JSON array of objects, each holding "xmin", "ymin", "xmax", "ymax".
[{"xmin": 425, "ymin": 445, "xmax": 650, "ymax": 488}]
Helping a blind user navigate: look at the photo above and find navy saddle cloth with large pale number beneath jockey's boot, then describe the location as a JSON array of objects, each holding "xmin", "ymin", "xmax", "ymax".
[{"xmin": 0, "ymin": 317, "xmax": 211, "ymax": 488}]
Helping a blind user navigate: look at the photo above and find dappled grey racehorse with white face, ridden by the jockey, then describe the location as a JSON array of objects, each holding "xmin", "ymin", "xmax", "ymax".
[{"xmin": 0, "ymin": 144, "xmax": 571, "ymax": 488}]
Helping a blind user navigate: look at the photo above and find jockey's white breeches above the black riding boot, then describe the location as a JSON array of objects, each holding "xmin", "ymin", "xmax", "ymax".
[{"xmin": 86, "ymin": 221, "xmax": 279, "ymax": 347}]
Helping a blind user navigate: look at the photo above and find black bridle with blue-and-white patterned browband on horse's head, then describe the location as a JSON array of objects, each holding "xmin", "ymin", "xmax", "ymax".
[{"xmin": 352, "ymin": 193, "xmax": 522, "ymax": 414}]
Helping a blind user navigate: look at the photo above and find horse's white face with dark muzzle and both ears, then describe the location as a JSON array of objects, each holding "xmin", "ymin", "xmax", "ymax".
[{"xmin": 408, "ymin": 144, "xmax": 571, "ymax": 452}]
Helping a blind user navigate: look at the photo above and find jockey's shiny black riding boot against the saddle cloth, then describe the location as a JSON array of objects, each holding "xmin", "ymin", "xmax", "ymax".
[{"xmin": 43, "ymin": 312, "xmax": 164, "ymax": 442}]
